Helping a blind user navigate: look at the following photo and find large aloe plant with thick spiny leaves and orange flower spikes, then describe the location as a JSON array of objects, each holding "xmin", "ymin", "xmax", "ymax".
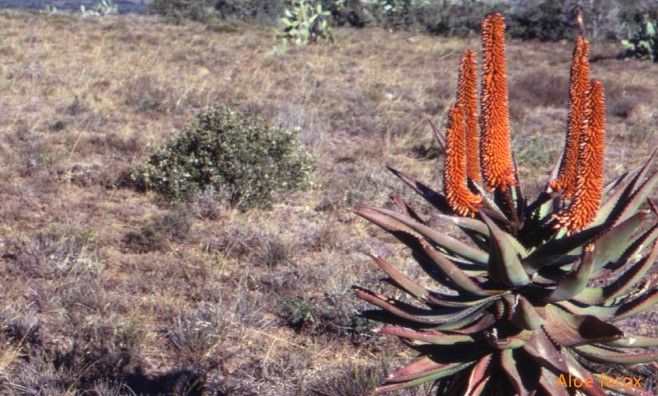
[{"xmin": 355, "ymin": 14, "xmax": 658, "ymax": 395}]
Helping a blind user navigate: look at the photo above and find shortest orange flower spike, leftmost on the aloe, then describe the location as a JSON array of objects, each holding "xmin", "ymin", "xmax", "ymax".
[{"xmin": 443, "ymin": 104, "xmax": 482, "ymax": 217}]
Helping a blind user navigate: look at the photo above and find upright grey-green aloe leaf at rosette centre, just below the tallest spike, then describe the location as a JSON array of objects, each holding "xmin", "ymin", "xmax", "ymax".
[{"xmin": 480, "ymin": 213, "xmax": 530, "ymax": 286}]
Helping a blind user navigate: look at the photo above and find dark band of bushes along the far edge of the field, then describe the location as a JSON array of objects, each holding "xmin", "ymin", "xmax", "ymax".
[{"xmin": 146, "ymin": 0, "xmax": 658, "ymax": 41}]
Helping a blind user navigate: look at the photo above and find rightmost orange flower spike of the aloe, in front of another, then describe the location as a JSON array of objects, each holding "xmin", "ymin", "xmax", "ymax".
[{"xmin": 557, "ymin": 81, "xmax": 605, "ymax": 233}]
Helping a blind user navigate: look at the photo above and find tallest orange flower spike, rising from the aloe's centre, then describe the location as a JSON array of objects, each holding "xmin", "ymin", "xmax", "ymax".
[{"xmin": 480, "ymin": 13, "xmax": 516, "ymax": 191}]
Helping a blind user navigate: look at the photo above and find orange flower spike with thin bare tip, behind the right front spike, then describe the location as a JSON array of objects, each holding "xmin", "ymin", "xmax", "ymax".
[{"xmin": 549, "ymin": 36, "xmax": 589, "ymax": 198}]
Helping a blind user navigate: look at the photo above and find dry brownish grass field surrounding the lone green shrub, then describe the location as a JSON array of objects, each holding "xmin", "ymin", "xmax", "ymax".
[{"xmin": 0, "ymin": 12, "xmax": 658, "ymax": 395}]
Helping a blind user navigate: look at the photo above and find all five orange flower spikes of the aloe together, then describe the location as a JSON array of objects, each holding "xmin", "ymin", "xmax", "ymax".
[{"xmin": 444, "ymin": 14, "xmax": 605, "ymax": 233}]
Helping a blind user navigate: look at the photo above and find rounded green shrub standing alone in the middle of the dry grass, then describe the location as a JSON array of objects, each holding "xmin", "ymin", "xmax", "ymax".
[{"xmin": 128, "ymin": 108, "xmax": 313, "ymax": 209}]
